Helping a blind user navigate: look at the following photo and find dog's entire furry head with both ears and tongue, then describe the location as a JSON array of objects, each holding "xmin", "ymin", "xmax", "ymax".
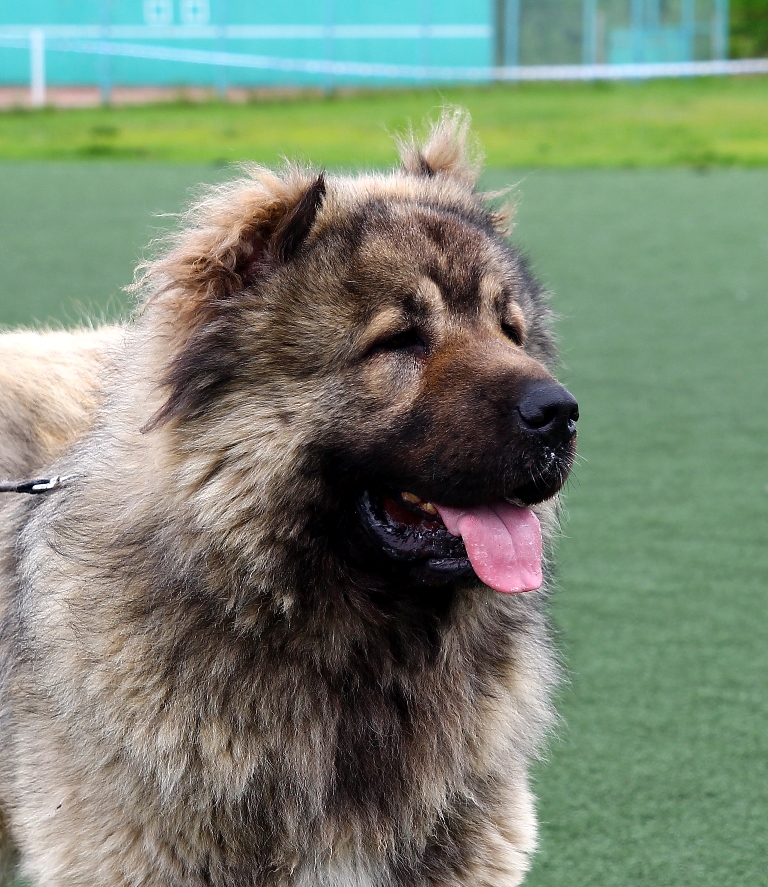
[{"xmin": 142, "ymin": 114, "xmax": 578, "ymax": 591}]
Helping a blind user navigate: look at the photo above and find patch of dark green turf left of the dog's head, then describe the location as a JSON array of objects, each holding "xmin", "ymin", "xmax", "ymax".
[{"xmin": 0, "ymin": 162, "xmax": 213, "ymax": 324}]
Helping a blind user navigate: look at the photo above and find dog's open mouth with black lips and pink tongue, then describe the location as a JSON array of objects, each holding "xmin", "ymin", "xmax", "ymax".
[{"xmin": 358, "ymin": 491, "xmax": 542, "ymax": 594}]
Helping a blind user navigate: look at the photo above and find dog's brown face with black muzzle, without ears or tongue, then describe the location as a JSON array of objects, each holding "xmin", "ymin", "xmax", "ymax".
[{"xmin": 273, "ymin": 194, "xmax": 578, "ymax": 582}]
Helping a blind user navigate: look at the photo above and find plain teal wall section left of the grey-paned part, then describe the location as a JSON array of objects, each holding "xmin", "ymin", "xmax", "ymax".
[{"xmin": 0, "ymin": 0, "xmax": 493, "ymax": 86}]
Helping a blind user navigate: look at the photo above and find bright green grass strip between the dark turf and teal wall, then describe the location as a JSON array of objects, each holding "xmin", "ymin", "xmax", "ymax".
[{"xmin": 0, "ymin": 77, "xmax": 768, "ymax": 168}]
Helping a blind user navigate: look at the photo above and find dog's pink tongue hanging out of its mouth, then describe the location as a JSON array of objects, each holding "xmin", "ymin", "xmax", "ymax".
[{"xmin": 435, "ymin": 501, "xmax": 542, "ymax": 594}]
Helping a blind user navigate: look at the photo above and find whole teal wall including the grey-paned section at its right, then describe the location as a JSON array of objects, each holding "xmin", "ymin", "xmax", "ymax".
[{"xmin": 0, "ymin": 0, "xmax": 728, "ymax": 89}]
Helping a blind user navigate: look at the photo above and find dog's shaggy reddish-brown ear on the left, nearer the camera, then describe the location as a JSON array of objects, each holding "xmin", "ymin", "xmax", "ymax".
[{"xmin": 138, "ymin": 168, "xmax": 326, "ymax": 431}]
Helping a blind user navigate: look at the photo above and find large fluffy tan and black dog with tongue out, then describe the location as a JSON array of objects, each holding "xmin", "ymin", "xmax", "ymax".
[{"xmin": 0, "ymin": 111, "xmax": 578, "ymax": 887}]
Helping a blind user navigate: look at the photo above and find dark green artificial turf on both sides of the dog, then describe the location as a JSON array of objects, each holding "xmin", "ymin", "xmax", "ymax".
[{"xmin": 0, "ymin": 163, "xmax": 768, "ymax": 887}]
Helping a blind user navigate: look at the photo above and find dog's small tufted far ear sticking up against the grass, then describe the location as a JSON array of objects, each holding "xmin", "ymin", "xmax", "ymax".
[{"xmin": 397, "ymin": 109, "xmax": 482, "ymax": 187}]
